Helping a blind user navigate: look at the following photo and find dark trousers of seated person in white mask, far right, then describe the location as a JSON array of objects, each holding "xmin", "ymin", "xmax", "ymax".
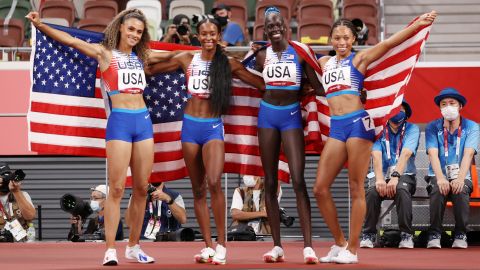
[{"xmin": 425, "ymin": 176, "xmax": 473, "ymax": 234}]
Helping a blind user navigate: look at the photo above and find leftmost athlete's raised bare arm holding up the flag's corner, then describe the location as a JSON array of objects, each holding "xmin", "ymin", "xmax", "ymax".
[{"xmin": 25, "ymin": 12, "xmax": 107, "ymax": 63}]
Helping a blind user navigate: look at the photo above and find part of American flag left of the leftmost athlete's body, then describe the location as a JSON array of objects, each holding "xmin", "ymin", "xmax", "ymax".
[{"xmin": 27, "ymin": 26, "xmax": 106, "ymax": 157}]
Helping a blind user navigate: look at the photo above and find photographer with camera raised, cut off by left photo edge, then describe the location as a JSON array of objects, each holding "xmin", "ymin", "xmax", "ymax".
[{"xmin": 0, "ymin": 162, "xmax": 36, "ymax": 242}]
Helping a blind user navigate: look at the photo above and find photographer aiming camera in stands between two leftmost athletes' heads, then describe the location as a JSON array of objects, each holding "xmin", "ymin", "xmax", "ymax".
[{"xmin": 160, "ymin": 14, "xmax": 200, "ymax": 46}]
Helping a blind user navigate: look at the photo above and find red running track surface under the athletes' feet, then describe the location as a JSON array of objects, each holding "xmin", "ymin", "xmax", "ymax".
[{"xmin": 0, "ymin": 242, "xmax": 480, "ymax": 270}]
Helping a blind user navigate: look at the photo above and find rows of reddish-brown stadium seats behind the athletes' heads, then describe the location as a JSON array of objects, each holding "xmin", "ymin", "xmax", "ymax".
[{"xmin": 0, "ymin": 0, "xmax": 379, "ymax": 47}]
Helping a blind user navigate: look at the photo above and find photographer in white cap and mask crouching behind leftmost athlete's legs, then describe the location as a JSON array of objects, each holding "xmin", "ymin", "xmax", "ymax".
[{"xmin": 67, "ymin": 185, "xmax": 123, "ymax": 242}]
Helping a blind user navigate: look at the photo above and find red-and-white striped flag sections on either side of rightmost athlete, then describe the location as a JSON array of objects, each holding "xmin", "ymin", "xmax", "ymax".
[{"xmin": 302, "ymin": 20, "xmax": 432, "ymax": 153}]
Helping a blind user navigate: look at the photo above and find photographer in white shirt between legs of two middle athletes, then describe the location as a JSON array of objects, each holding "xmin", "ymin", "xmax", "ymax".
[{"xmin": 230, "ymin": 175, "xmax": 282, "ymax": 234}]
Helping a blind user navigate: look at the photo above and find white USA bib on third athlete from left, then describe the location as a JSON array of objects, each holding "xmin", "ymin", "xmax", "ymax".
[{"xmin": 263, "ymin": 63, "xmax": 297, "ymax": 86}]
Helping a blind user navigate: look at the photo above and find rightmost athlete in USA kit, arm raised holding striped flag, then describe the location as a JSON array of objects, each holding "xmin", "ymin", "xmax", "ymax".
[{"xmin": 313, "ymin": 11, "xmax": 437, "ymax": 264}]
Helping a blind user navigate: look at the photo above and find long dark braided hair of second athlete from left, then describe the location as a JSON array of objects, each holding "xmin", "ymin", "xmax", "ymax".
[{"xmin": 197, "ymin": 18, "xmax": 232, "ymax": 117}]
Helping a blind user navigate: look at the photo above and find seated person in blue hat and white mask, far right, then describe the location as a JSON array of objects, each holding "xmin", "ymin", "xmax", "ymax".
[{"xmin": 425, "ymin": 88, "xmax": 480, "ymax": 248}]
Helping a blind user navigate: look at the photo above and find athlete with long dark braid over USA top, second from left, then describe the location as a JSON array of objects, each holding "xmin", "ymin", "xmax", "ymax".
[{"xmin": 149, "ymin": 18, "xmax": 265, "ymax": 264}]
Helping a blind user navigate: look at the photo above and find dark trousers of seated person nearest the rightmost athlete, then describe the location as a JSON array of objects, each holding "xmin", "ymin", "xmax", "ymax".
[{"xmin": 363, "ymin": 175, "xmax": 417, "ymax": 234}]
